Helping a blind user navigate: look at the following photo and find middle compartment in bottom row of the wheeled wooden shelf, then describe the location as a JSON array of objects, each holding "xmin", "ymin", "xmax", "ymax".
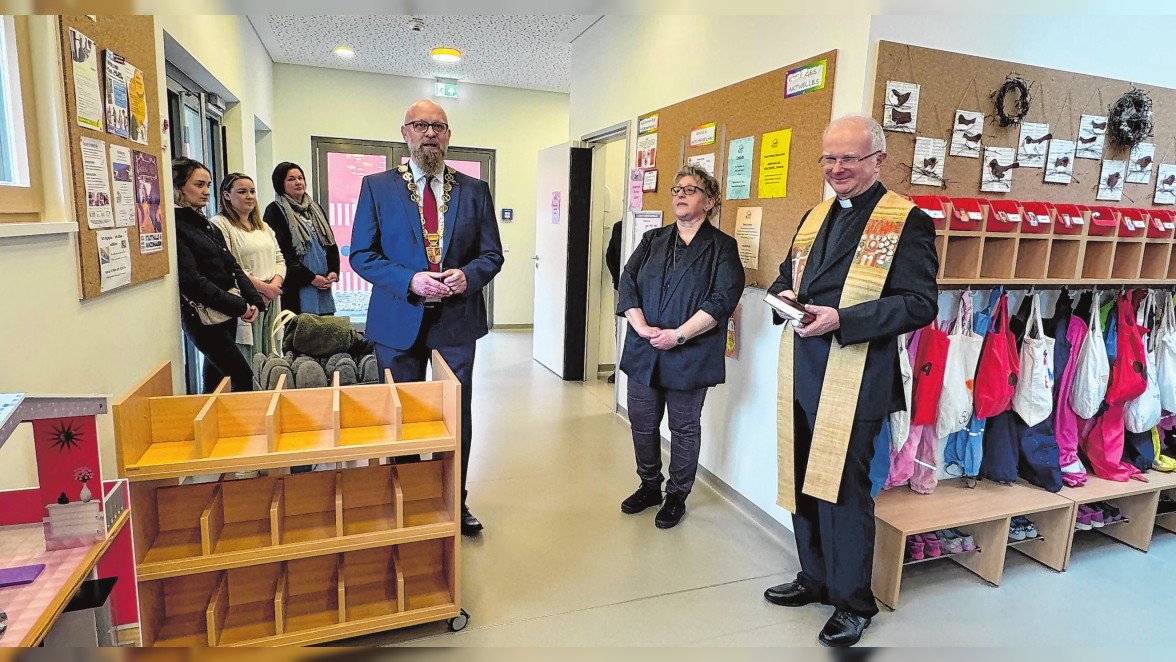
[{"xmin": 274, "ymin": 554, "xmax": 346, "ymax": 635}]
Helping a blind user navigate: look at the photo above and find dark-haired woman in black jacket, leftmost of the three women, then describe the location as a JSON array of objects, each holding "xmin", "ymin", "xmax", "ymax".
[{"xmin": 172, "ymin": 158, "xmax": 263, "ymax": 393}]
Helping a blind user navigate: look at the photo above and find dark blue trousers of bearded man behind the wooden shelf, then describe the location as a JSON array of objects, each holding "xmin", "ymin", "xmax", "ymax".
[{"xmin": 375, "ymin": 312, "xmax": 476, "ymax": 506}]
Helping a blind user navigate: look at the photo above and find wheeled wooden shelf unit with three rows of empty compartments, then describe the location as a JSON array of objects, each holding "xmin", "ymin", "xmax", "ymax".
[{"xmin": 113, "ymin": 354, "xmax": 468, "ymax": 646}]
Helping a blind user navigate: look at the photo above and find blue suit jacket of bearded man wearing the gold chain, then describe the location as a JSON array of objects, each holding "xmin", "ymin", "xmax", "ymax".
[{"xmin": 350, "ymin": 168, "xmax": 502, "ymax": 349}]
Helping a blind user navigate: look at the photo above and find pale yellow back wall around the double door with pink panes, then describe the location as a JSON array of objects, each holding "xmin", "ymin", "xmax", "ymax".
[{"xmin": 269, "ymin": 63, "xmax": 568, "ymax": 325}]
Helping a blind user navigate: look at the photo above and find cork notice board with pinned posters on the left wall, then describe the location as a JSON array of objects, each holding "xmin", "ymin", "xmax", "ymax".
[{"xmin": 61, "ymin": 15, "xmax": 172, "ymax": 299}]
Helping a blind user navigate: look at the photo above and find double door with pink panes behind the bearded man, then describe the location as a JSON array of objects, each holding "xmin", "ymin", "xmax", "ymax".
[{"xmin": 310, "ymin": 136, "xmax": 494, "ymax": 329}]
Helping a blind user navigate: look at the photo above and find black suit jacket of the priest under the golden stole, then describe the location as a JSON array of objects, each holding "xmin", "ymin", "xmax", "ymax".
[{"xmin": 768, "ymin": 183, "xmax": 940, "ymax": 421}]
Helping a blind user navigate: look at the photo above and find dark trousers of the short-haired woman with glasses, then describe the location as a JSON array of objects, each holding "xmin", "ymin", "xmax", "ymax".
[{"xmin": 629, "ymin": 380, "xmax": 707, "ymax": 499}]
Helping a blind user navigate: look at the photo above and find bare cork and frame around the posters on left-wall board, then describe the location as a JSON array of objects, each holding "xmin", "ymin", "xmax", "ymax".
[{"xmin": 60, "ymin": 15, "xmax": 172, "ymax": 299}]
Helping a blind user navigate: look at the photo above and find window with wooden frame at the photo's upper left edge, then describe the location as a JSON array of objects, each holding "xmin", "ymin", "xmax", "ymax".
[{"xmin": 0, "ymin": 14, "xmax": 42, "ymax": 221}]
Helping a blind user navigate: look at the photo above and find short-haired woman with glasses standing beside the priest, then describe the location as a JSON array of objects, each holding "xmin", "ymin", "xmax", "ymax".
[{"xmin": 616, "ymin": 166, "xmax": 744, "ymax": 529}]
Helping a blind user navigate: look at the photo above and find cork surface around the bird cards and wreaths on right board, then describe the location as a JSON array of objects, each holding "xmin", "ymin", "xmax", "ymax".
[{"xmin": 873, "ymin": 41, "xmax": 1176, "ymax": 205}]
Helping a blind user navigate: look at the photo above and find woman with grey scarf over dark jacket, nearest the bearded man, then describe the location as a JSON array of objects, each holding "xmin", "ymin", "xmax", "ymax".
[{"xmin": 262, "ymin": 161, "xmax": 339, "ymax": 315}]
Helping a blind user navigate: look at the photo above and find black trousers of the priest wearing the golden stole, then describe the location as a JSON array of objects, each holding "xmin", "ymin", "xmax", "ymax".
[{"xmin": 793, "ymin": 402, "xmax": 882, "ymax": 617}]
